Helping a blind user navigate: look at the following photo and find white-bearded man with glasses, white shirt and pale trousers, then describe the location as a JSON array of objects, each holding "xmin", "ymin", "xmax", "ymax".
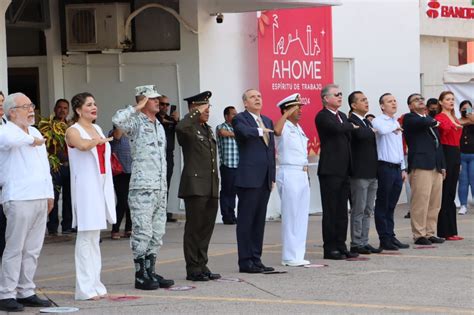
[{"xmin": 0, "ymin": 93, "xmax": 54, "ymax": 312}]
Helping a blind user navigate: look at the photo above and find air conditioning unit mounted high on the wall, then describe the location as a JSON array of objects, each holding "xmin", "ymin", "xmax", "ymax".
[{"xmin": 66, "ymin": 3, "xmax": 130, "ymax": 51}]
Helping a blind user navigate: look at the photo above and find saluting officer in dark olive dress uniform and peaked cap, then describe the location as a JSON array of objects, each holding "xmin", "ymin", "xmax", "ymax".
[{"xmin": 176, "ymin": 91, "xmax": 221, "ymax": 281}]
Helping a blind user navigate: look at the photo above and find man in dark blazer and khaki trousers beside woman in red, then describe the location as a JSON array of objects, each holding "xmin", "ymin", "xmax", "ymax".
[{"xmin": 403, "ymin": 93, "xmax": 446, "ymax": 245}]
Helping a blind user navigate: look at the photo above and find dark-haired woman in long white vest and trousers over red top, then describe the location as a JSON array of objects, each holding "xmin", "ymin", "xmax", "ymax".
[{"xmin": 66, "ymin": 92, "xmax": 116, "ymax": 300}]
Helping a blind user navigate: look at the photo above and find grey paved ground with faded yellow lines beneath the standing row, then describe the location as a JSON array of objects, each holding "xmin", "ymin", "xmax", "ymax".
[{"xmin": 5, "ymin": 206, "xmax": 474, "ymax": 314}]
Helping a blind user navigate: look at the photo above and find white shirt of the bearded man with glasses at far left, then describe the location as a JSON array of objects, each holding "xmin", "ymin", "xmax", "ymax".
[{"xmin": 0, "ymin": 122, "xmax": 54, "ymax": 202}]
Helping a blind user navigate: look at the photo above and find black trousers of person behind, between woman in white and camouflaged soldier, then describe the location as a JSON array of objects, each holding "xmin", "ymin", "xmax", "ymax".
[{"xmin": 112, "ymin": 173, "xmax": 132, "ymax": 233}]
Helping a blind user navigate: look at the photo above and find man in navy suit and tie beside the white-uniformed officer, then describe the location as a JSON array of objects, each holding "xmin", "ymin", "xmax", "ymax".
[{"xmin": 232, "ymin": 89, "xmax": 275, "ymax": 273}]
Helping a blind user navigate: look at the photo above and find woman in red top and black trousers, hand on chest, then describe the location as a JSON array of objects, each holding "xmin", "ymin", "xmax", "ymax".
[{"xmin": 435, "ymin": 91, "xmax": 463, "ymax": 241}]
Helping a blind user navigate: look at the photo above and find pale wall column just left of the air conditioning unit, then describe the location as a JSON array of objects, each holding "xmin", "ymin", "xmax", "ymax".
[{"xmin": 44, "ymin": 0, "xmax": 66, "ymax": 112}]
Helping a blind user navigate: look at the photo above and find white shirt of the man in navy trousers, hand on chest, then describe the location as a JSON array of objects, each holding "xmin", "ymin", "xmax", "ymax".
[{"xmin": 372, "ymin": 114, "xmax": 405, "ymax": 170}]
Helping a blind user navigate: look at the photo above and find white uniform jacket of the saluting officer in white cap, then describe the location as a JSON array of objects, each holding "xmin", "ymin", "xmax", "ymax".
[{"xmin": 275, "ymin": 120, "xmax": 308, "ymax": 166}]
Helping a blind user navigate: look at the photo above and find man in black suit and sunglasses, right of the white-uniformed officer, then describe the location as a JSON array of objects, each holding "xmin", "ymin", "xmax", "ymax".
[{"xmin": 315, "ymin": 84, "xmax": 359, "ymax": 260}]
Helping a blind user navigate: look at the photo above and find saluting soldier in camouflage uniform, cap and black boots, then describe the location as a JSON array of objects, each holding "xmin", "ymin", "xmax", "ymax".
[{"xmin": 112, "ymin": 85, "xmax": 174, "ymax": 290}]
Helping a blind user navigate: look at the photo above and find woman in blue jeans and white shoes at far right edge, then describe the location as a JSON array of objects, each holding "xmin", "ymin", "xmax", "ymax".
[{"xmin": 458, "ymin": 100, "xmax": 474, "ymax": 215}]
